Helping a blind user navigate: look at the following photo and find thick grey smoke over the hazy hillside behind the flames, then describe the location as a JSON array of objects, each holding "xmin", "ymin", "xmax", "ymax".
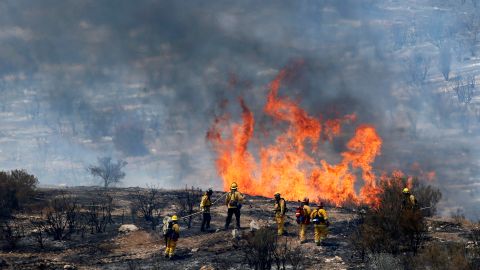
[{"xmin": 0, "ymin": 0, "xmax": 480, "ymax": 217}]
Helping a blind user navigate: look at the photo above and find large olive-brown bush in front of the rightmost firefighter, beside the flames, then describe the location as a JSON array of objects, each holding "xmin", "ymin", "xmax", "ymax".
[{"xmin": 352, "ymin": 176, "xmax": 441, "ymax": 258}]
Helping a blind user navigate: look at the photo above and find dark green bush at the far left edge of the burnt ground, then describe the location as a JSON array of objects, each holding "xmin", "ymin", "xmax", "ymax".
[{"xmin": 0, "ymin": 170, "xmax": 38, "ymax": 219}]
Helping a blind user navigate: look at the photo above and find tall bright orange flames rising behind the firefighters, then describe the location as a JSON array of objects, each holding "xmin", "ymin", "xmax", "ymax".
[{"xmin": 207, "ymin": 66, "xmax": 382, "ymax": 205}]
